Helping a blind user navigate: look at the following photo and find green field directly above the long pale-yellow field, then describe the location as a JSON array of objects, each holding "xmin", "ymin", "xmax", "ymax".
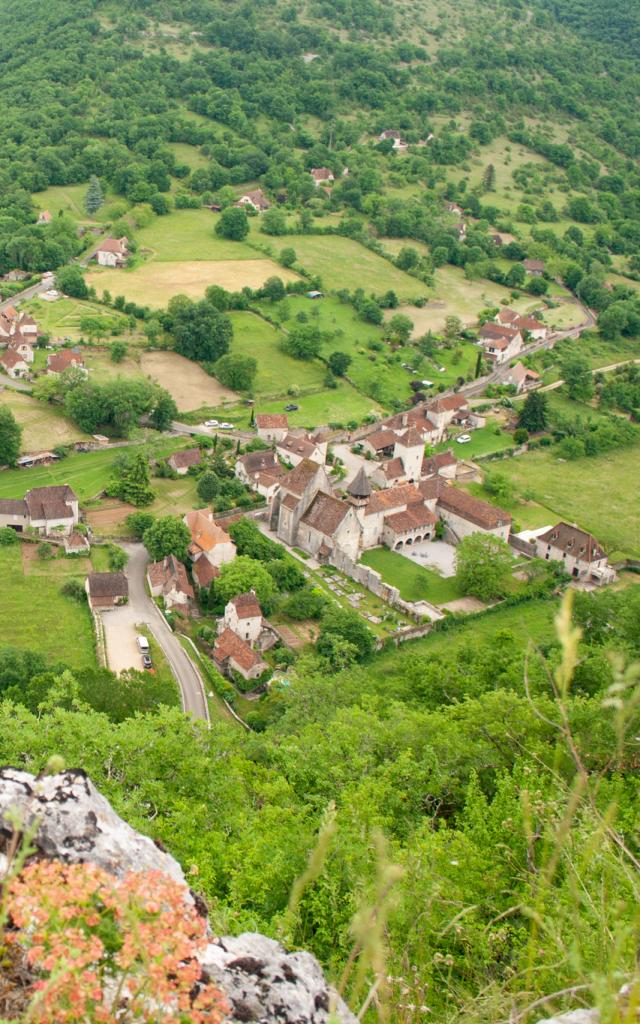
[{"xmin": 135, "ymin": 207, "xmax": 259, "ymax": 263}]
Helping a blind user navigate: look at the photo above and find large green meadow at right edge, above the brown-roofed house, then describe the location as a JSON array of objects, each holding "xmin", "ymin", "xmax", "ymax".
[{"xmin": 499, "ymin": 445, "xmax": 640, "ymax": 558}]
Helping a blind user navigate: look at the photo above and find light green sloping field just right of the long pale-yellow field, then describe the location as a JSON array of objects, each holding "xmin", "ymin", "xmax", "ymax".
[{"xmin": 279, "ymin": 234, "xmax": 429, "ymax": 302}]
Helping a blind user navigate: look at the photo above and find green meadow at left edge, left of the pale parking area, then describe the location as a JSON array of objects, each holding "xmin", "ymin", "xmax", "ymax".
[{"xmin": 0, "ymin": 544, "xmax": 95, "ymax": 669}]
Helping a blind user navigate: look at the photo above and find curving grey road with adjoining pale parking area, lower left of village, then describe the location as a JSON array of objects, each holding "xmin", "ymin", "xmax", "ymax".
[{"xmin": 102, "ymin": 544, "xmax": 209, "ymax": 722}]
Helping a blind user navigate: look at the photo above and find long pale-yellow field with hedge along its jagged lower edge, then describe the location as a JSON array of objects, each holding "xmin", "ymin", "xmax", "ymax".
[{"xmin": 86, "ymin": 259, "xmax": 297, "ymax": 309}]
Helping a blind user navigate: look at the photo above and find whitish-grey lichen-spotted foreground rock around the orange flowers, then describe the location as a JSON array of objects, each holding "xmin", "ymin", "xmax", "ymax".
[{"xmin": 0, "ymin": 768, "xmax": 356, "ymax": 1024}]
